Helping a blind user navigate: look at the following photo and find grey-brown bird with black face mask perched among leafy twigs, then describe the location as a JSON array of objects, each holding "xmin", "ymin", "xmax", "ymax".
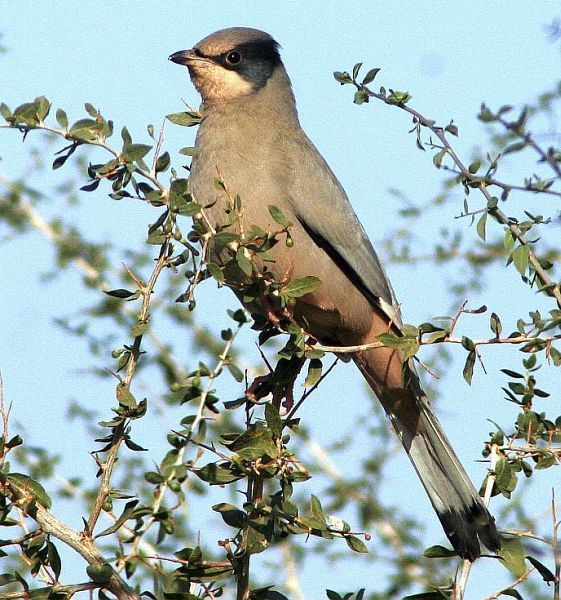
[{"xmin": 170, "ymin": 27, "xmax": 500, "ymax": 561}]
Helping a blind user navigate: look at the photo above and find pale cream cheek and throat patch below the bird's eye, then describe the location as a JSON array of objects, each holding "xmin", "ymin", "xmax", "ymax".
[{"xmin": 191, "ymin": 63, "xmax": 254, "ymax": 102}]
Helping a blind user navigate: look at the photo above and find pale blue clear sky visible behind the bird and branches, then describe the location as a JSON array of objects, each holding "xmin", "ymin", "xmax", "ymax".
[{"xmin": 0, "ymin": 0, "xmax": 561, "ymax": 599}]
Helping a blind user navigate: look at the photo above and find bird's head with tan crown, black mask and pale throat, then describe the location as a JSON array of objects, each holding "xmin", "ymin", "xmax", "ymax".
[{"xmin": 169, "ymin": 27, "xmax": 282, "ymax": 103}]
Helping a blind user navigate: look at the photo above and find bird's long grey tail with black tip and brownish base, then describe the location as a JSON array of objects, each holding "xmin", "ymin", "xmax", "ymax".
[{"xmin": 354, "ymin": 348, "xmax": 500, "ymax": 561}]
